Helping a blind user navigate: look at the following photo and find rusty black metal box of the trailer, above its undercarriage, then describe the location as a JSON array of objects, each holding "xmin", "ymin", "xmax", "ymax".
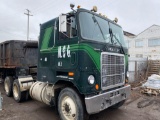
[{"xmin": 0, "ymin": 40, "xmax": 38, "ymax": 68}]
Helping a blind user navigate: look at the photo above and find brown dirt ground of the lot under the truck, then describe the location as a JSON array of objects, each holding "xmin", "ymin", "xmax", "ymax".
[{"xmin": 0, "ymin": 83, "xmax": 160, "ymax": 120}]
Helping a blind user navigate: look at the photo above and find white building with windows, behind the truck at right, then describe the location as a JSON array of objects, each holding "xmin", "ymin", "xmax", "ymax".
[{"xmin": 124, "ymin": 25, "xmax": 160, "ymax": 59}]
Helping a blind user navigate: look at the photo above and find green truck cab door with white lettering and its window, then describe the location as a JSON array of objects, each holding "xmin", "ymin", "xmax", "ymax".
[{"xmin": 56, "ymin": 15, "xmax": 78, "ymax": 70}]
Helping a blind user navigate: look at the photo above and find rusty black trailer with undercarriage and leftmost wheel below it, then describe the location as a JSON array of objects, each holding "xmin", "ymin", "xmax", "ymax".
[{"xmin": 0, "ymin": 40, "xmax": 38, "ymax": 100}]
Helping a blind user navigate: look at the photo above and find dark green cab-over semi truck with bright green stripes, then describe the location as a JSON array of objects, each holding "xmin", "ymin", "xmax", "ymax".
[{"xmin": 3, "ymin": 5, "xmax": 131, "ymax": 120}]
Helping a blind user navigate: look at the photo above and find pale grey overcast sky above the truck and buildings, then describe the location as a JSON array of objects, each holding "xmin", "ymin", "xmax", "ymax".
[{"xmin": 0, "ymin": 0, "xmax": 160, "ymax": 41}]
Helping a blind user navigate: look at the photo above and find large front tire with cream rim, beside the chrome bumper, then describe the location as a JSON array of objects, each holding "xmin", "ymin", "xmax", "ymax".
[{"xmin": 58, "ymin": 88, "xmax": 86, "ymax": 120}]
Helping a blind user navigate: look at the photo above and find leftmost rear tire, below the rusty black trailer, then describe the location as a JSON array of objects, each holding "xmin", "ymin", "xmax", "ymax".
[{"xmin": 4, "ymin": 76, "xmax": 13, "ymax": 97}]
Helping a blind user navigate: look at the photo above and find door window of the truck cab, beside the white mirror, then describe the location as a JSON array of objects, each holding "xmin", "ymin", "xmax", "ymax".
[{"xmin": 59, "ymin": 16, "xmax": 77, "ymax": 40}]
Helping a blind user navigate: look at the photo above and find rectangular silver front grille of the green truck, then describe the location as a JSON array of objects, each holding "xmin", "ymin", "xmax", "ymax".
[{"xmin": 101, "ymin": 52, "xmax": 125, "ymax": 89}]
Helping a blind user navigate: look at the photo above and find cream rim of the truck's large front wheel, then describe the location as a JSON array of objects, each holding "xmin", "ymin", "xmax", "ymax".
[{"xmin": 61, "ymin": 96, "xmax": 77, "ymax": 120}]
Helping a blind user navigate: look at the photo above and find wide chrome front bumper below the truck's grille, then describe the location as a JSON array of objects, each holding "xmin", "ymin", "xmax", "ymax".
[{"xmin": 85, "ymin": 85, "xmax": 131, "ymax": 114}]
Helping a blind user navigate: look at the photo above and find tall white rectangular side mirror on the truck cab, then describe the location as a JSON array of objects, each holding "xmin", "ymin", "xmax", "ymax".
[{"xmin": 59, "ymin": 14, "xmax": 67, "ymax": 32}]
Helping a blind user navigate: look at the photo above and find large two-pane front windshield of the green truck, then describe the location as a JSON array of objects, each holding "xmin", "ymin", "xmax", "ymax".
[{"xmin": 79, "ymin": 12, "xmax": 126, "ymax": 47}]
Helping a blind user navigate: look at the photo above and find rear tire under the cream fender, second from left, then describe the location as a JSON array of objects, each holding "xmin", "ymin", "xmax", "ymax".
[{"xmin": 13, "ymin": 79, "xmax": 29, "ymax": 103}]
